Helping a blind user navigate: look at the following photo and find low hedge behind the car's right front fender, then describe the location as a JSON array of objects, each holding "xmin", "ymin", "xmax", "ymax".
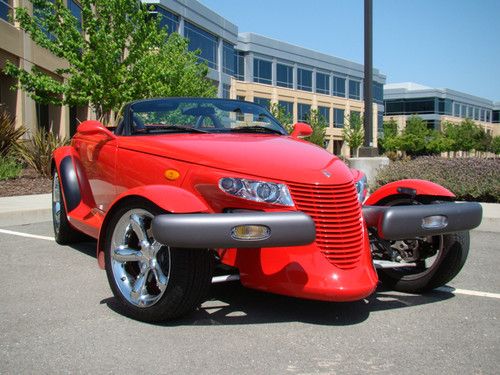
[{"xmin": 373, "ymin": 156, "xmax": 500, "ymax": 203}]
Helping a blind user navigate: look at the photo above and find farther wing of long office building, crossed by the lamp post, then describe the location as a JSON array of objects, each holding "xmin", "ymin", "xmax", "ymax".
[{"xmin": 230, "ymin": 33, "xmax": 385, "ymax": 155}]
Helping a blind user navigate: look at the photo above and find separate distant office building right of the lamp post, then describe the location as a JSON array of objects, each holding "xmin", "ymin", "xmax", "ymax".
[{"xmin": 384, "ymin": 82, "xmax": 500, "ymax": 135}]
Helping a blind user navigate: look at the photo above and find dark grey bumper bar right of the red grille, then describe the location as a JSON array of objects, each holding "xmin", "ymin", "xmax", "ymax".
[{"xmin": 363, "ymin": 202, "xmax": 483, "ymax": 240}]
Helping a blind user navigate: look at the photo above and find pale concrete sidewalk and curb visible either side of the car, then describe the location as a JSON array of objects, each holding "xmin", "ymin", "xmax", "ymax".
[{"xmin": 0, "ymin": 194, "xmax": 500, "ymax": 233}]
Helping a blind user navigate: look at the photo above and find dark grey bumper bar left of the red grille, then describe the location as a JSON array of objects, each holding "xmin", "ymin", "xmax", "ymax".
[{"xmin": 152, "ymin": 211, "xmax": 316, "ymax": 248}]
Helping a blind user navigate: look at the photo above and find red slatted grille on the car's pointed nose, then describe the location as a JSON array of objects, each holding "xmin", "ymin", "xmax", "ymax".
[{"xmin": 288, "ymin": 183, "xmax": 363, "ymax": 269}]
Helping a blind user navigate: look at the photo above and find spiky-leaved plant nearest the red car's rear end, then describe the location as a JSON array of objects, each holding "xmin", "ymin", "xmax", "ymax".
[{"xmin": 17, "ymin": 129, "xmax": 69, "ymax": 177}]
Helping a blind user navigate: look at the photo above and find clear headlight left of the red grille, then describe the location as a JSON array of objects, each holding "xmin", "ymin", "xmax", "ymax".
[{"xmin": 219, "ymin": 177, "xmax": 293, "ymax": 206}]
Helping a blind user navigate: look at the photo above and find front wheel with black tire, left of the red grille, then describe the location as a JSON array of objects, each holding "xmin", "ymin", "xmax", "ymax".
[{"xmin": 104, "ymin": 199, "xmax": 214, "ymax": 323}]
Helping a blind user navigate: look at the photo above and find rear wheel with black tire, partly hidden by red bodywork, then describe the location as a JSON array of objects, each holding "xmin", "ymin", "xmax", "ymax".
[{"xmin": 52, "ymin": 170, "xmax": 85, "ymax": 245}]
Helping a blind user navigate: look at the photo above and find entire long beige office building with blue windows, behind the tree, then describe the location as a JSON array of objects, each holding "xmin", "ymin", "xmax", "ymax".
[{"xmin": 0, "ymin": 0, "xmax": 385, "ymax": 155}]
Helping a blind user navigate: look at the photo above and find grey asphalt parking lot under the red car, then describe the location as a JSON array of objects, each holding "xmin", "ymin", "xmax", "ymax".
[{"xmin": 0, "ymin": 222, "xmax": 500, "ymax": 374}]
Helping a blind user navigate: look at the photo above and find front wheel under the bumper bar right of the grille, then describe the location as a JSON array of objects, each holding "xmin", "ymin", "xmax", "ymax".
[{"xmin": 372, "ymin": 200, "xmax": 470, "ymax": 293}]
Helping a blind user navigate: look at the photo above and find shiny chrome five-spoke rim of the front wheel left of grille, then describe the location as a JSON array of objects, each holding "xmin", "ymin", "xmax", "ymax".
[{"xmin": 111, "ymin": 209, "xmax": 170, "ymax": 307}]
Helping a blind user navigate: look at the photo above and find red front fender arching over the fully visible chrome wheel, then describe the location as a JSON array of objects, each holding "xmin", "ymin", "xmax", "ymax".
[{"xmin": 97, "ymin": 185, "xmax": 211, "ymax": 269}]
